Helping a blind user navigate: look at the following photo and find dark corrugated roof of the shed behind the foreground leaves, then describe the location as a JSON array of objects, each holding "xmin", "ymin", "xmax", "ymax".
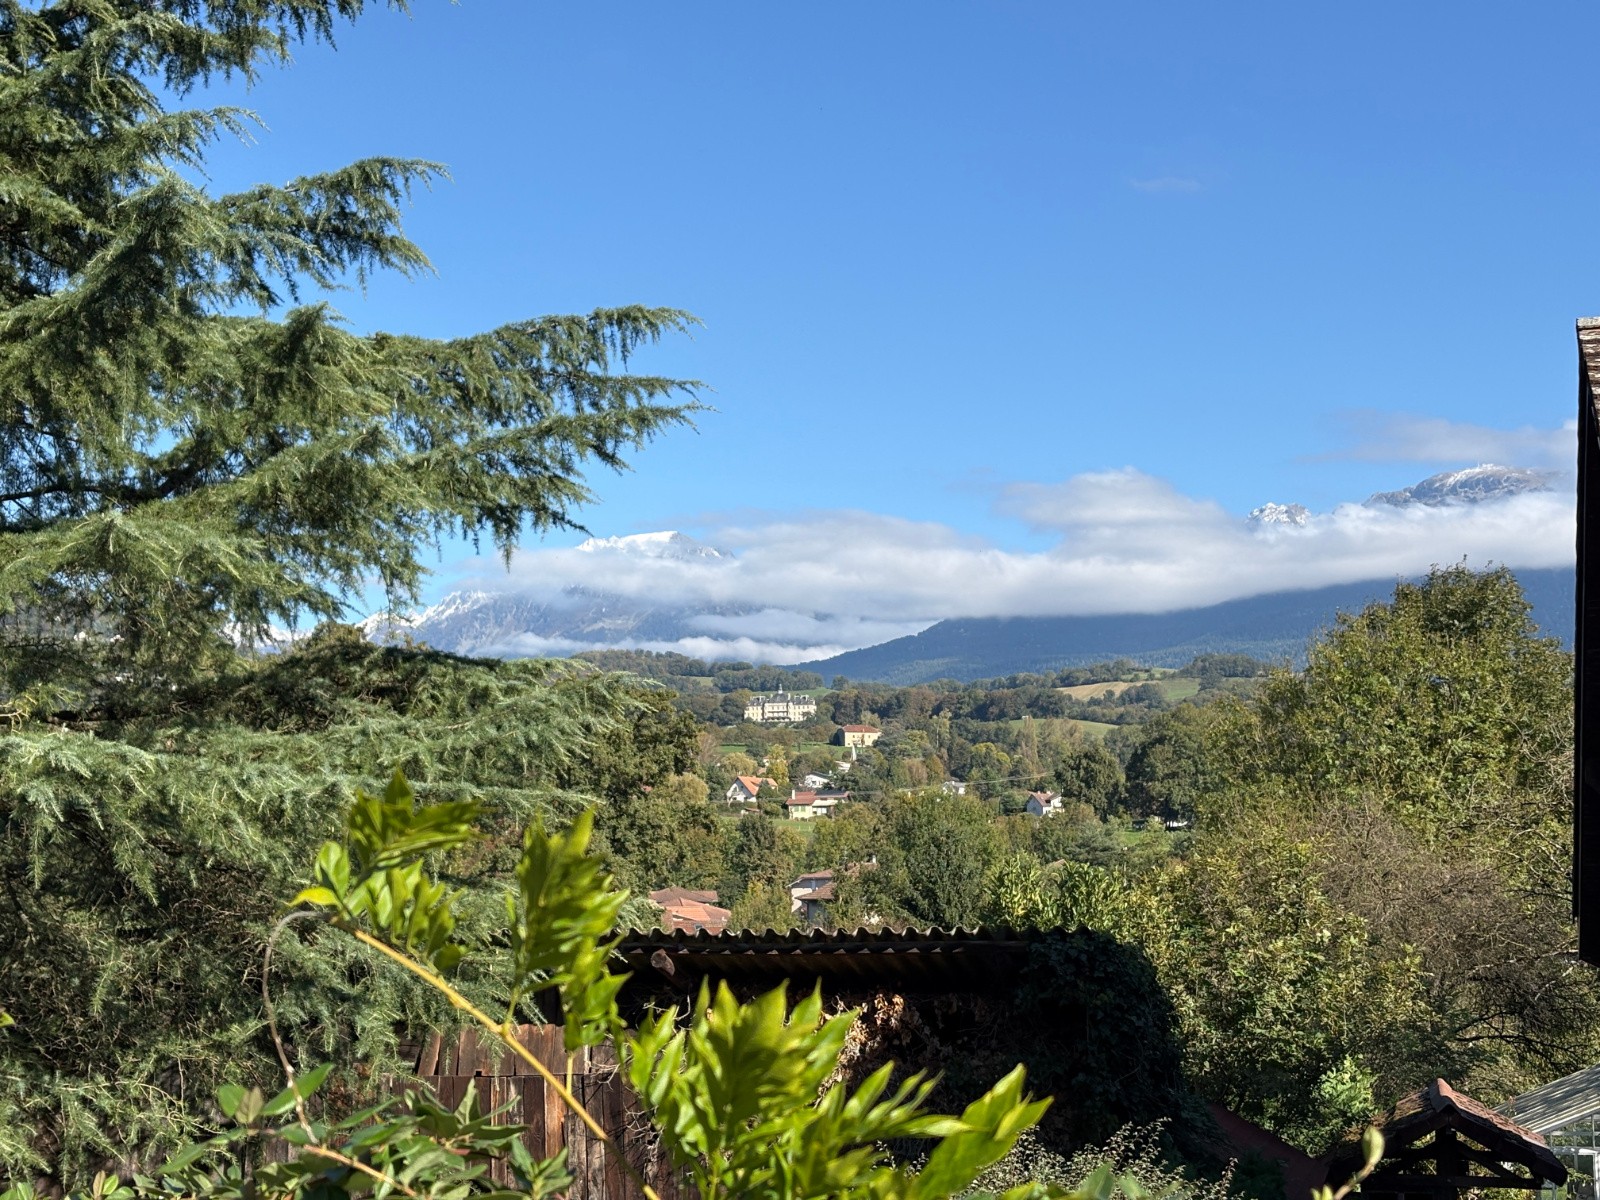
[{"xmin": 618, "ymin": 928, "xmax": 1040, "ymax": 992}]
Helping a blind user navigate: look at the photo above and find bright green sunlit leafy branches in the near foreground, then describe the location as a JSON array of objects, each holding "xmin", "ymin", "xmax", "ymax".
[{"xmin": 78, "ymin": 773, "xmax": 1062, "ymax": 1200}]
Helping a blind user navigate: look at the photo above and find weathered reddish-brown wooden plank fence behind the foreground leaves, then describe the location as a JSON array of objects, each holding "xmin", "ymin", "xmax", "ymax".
[{"xmin": 260, "ymin": 1026, "xmax": 694, "ymax": 1200}]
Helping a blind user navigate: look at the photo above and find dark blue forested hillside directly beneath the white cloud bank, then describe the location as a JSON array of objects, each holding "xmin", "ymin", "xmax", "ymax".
[{"xmin": 797, "ymin": 566, "xmax": 1573, "ymax": 686}]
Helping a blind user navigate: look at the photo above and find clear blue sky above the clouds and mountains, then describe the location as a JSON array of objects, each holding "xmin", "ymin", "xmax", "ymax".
[{"xmin": 193, "ymin": 0, "xmax": 1600, "ymax": 652}]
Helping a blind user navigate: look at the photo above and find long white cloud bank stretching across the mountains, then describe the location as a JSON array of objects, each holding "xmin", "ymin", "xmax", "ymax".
[{"xmin": 406, "ymin": 422, "xmax": 1574, "ymax": 662}]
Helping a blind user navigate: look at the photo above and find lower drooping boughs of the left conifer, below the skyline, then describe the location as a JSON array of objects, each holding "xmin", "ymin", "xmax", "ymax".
[{"xmin": 0, "ymin": 627, "xmax": 693, "ymax": 1181}]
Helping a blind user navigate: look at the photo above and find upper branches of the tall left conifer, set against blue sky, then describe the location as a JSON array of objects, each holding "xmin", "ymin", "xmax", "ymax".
[{"xmin": 0, "ymin": 0, "xmax": 694, "ymax": 714}]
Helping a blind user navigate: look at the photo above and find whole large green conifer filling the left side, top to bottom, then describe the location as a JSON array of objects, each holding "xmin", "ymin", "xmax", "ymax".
[{"xmin": 0, "ymin": 0, "xmax": 696, "ymax": 1186}]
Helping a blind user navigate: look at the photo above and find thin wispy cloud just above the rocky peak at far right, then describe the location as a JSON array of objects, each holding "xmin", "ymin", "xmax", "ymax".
[{"xmin": 1317, "ymin": 408, "xmax": 1578, "ymax": 472}]
